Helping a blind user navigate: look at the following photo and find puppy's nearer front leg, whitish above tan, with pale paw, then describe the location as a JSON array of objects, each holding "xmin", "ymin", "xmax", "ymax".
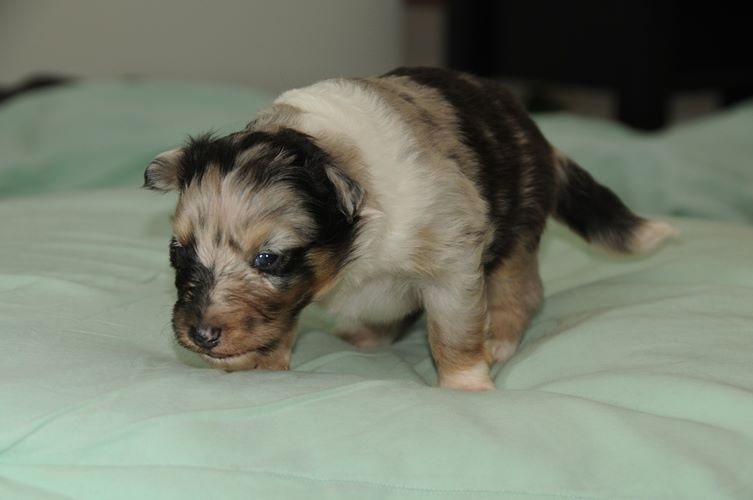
[{"xmin": 423, "ymin": 276, "xmax": 494, "ymax": 391}]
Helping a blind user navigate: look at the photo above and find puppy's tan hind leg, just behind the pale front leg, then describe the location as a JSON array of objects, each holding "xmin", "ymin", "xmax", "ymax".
[{"xmin": 486, "ymin": 245, "xmax": 543, "ymax": 362}]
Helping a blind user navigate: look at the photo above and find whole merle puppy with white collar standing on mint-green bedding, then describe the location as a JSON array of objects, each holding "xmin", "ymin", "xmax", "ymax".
[{"xmin": 144, "ymin": 68, "xmax": 673, "ymax": 390}]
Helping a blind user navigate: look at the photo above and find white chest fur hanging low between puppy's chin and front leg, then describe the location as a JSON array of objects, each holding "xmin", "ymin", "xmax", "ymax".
[{"xmin": 318, "ymin": 274, "xmax": 420, "ymax": 324}]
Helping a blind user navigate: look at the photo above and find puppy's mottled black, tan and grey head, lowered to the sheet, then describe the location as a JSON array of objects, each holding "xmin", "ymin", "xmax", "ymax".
[{"xmin": 144, "ymin": 129, "xmax": 363, "ymax": 370}]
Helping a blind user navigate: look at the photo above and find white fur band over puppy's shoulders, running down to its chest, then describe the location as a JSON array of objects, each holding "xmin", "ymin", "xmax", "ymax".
[{"xmin": 275, "ymin": 79, "xmax": 488, "ymax": 322}]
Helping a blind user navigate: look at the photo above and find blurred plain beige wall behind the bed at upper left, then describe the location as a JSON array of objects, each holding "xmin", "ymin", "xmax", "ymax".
[{"xmin": 0, "ymin": 0, "xmax": 403, "ymax": 91}]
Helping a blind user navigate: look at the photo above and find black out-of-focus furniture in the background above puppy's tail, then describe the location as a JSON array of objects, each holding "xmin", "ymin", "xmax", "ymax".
[{"xmin": 446, "ymin": 0, "xmax": 753, "ymax": 130}]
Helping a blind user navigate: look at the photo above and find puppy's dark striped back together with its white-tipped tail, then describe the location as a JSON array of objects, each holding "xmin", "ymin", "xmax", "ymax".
[{"xmin": 378, "ymin": 68, "xmax": 676, "ymax": 262}]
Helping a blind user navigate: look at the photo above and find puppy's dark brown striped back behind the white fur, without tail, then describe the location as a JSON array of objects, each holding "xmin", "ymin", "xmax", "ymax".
[{"xmin": 370, "ymin": 68, "xmax": 556, "ymax": 268}]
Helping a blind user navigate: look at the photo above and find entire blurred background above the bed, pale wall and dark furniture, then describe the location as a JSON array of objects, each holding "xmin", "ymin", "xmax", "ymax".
[{"xmin": 0, "ymin": 0, "xmax": 753, "ymax": 130}]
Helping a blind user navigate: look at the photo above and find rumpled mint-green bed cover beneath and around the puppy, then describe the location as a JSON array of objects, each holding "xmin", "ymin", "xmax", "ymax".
[{"xmin": 0, "ymin": 81, "xmax": 753, "ymax": 499}]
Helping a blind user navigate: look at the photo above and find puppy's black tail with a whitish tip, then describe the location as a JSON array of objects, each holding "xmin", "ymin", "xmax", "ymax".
[{"xmin": 554, "ymin": 152, "xmax": 678, "ymax": 253}]
